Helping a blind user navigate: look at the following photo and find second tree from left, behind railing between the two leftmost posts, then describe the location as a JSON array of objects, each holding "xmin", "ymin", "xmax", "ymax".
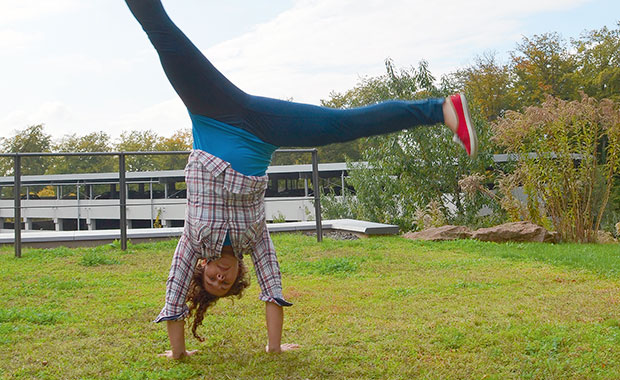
[{"xmin": 47, "ymin": 132, "xmax": 118, "ymax": 174}]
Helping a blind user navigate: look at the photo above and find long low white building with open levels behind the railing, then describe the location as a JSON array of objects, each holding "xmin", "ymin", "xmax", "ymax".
[{"xmin": 0, "ymin": 163, "xmax": 354, "ymax": 232}]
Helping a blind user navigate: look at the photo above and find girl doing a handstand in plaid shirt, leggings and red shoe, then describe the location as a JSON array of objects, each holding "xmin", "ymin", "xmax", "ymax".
[{"xmin": 126, "ymin": 0, "xmax": 478, "ymax": 359}]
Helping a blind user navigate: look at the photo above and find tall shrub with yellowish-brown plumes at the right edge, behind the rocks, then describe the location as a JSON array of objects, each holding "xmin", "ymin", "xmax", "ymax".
[{"xmin": 493, "ymin": 95, "xmax": 620, "ymax": 242}]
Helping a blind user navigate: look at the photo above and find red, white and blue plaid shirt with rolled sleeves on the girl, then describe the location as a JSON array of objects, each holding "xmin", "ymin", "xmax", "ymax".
[{"xmin": 155, "ymin": 150, "xmax": 290, "ymax": 322}]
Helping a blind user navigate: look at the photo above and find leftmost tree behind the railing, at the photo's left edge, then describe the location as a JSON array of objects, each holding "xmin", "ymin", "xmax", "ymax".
[{"xmin": 0, "ymin": 124, "xmax": 52, "ymax": 175}]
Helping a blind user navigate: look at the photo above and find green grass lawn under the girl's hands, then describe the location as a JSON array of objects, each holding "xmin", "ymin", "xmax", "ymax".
[{"xmin": 0, "ymin": 234, "xmax": 620, "ymax": 379}]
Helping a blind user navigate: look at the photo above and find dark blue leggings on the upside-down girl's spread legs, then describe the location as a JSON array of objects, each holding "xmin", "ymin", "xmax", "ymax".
[{"xmin": 126, "ymin": 0, "xmax": 444, "ymax": 147}]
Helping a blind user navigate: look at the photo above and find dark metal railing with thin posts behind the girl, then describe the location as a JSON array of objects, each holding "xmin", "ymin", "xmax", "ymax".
[{"xmin": 0, "ymin": 148, "xmax": 323, "ymax": 257}]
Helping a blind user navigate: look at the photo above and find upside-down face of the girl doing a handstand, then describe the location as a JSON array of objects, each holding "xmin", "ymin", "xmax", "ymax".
[{"xmin": 202, "ymin": 246, "xmax": 239, "ymax": 297}]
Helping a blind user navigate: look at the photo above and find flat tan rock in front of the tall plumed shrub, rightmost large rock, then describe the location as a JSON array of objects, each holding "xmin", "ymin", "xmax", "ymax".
[{"xmin": 472, "ymin": 222, "xmax": 557, "ymax": 242}]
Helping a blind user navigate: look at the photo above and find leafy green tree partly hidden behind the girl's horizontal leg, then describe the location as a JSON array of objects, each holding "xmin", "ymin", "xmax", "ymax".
[{"xmin": 325, "ymin": 59, "xmax": 490, "ymax": 230}]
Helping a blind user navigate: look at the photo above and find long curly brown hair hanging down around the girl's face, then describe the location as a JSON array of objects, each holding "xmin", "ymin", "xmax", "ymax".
[{"xmin": 187, "ymin": 260, "xmax": 250, "ymax": 342}]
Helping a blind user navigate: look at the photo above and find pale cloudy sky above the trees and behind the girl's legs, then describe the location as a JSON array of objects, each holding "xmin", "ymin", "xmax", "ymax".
[{"xmin": 0, "ymin": 0, "xmax": 620, "ymax": 139}]
